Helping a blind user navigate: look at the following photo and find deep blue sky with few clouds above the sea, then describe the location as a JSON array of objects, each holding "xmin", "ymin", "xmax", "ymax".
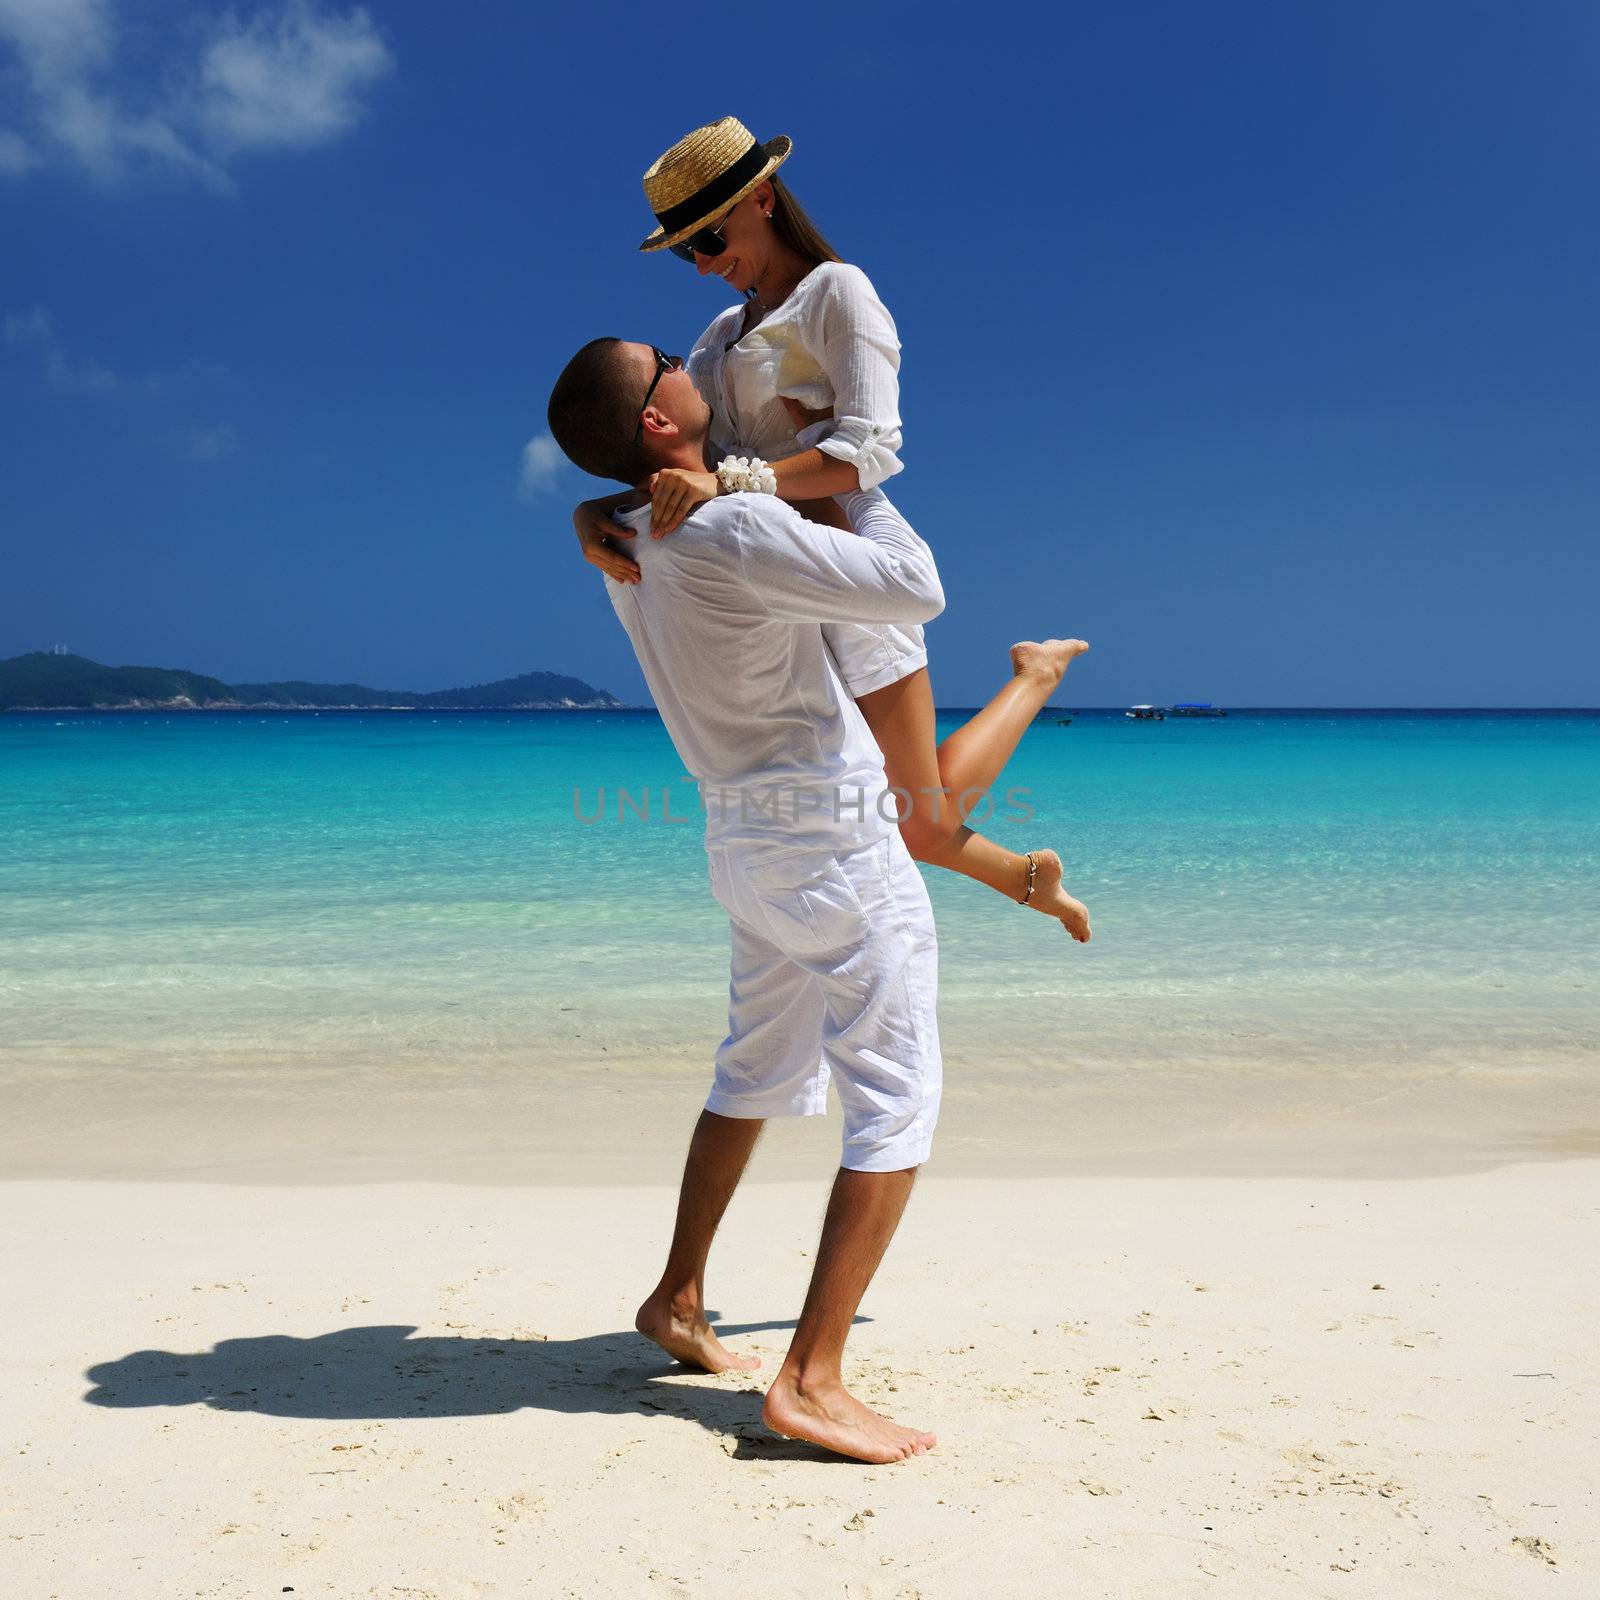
[{"xmin": 0, "ymin": 0, "xmax": 1600, "ymax": 706}]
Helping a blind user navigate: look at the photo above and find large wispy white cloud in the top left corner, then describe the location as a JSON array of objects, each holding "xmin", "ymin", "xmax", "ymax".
[{"xmin": 0, "ymin": 0, "xmax": 394, "ymax": 192}]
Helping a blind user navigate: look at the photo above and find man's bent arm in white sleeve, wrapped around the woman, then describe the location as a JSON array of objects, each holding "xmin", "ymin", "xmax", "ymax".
[{"xmin": 738, "ymin": 490, "xmax": 944, "ymax": 622}]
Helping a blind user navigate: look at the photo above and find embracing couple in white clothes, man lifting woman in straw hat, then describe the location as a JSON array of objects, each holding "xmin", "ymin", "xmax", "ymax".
[{"xmin": 549, "ymin": 117, "xmax": 1090, "ymax": 1462}]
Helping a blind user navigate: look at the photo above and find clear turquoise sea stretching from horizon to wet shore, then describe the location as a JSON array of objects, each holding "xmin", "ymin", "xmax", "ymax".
[{"xmin": 0, "ymin": 712, "xmax": 1600, "ymax": 1100}]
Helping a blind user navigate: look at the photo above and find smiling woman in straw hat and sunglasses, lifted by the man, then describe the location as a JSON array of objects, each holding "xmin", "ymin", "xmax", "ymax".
[{"xmin": 574, "ymin": 117, "xmax": 1090, "ymax": 942}]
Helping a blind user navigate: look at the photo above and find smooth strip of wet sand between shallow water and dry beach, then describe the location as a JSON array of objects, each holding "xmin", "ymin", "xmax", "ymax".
[{"xmin": 0, "ymin": 1043, "xmax": 1600, "ymax": 1186}]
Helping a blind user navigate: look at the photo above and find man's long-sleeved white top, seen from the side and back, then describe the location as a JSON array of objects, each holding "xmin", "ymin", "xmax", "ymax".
[{"xmin": 605, "ymin": 490, "xmax": 944, "ymax": 851}]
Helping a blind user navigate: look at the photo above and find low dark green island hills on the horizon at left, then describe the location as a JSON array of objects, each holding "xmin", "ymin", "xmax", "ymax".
[{"xmin": 0, "ymin": 650, "xmax": 622, "ymax": 710}]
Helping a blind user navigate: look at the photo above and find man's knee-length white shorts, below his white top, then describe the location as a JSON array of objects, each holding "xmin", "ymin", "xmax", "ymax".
[{"xmin": 706, "ymin": 832, "xmax": 942, "ymax": 1173}]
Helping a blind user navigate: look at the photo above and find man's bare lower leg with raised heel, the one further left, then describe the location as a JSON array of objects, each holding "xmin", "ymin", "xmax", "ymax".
[{"xmin": 634, "ymin": 1110, "xmax": 764, "ymax": 1373}]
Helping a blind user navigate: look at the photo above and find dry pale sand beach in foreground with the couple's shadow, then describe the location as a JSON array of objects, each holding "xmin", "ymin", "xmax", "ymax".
[{"xmin": 0, "ymin": 1139, "xmax": 1600, "ymax": 1600}]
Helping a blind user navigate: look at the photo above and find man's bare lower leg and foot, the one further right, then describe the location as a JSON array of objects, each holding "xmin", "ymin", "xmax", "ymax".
[{"xmin": 762, "ymin": 1166, "xmax": 936, "ymax": 1461}]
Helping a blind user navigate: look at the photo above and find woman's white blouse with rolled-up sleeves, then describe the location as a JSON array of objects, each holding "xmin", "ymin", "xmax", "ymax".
[{"xmin": 686, "ymin": 261, "xmax": 901, "ymax": 490}]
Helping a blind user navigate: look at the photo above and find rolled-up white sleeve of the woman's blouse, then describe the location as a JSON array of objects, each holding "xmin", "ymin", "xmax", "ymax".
[{"xmin": 797, "ymin": 262, "xmax": 902, "ymax": 490}]
